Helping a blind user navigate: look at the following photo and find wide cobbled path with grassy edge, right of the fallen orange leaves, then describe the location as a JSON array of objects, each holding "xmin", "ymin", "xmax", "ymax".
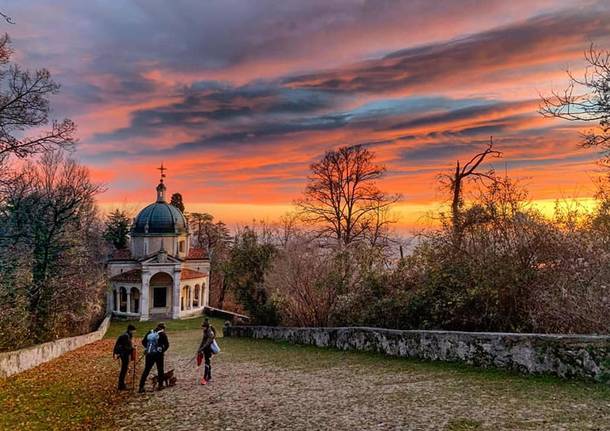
[{"xmin": 118, "ymin": 333, "xmax": 610, "ymax": 431}]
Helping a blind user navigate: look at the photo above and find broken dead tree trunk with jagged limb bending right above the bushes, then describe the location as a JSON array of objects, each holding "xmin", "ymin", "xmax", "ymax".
[{"xmin": 441, "ymin": 138, "xmax": 502, "ymax": 247}]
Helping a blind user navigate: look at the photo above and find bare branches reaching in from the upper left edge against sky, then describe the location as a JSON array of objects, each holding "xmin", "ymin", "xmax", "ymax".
[{"xmin": 0, "ymin": 34, "xmax": 76, "ymax": 167}]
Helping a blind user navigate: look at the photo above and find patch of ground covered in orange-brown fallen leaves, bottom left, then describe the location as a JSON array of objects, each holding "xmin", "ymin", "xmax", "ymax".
[{"xmin": 0, "ymin": 340, "xmax": 130, "ymax": 430}]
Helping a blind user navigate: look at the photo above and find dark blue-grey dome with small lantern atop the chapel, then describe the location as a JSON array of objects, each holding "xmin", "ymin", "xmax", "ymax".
[{"xmin": 132, "ymin": 182, "xmax": 186, "ymax": 234}]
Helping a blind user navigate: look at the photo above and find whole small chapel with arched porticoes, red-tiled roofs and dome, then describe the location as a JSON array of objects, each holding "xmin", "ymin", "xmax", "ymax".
[{"xmin": 107, "ymin": 171, "xmax": 210, "ymax": 320}]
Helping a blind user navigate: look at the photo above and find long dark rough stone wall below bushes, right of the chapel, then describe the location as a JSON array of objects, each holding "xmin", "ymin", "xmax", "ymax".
[{"xmin": 224, "ymin": 326, "xmax": 610, "ymax": 383}]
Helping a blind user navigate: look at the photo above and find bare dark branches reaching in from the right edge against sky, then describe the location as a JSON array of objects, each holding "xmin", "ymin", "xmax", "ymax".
[{"xmin": 539, "ymin": 44, "xmax": 610, "ymax": 164}]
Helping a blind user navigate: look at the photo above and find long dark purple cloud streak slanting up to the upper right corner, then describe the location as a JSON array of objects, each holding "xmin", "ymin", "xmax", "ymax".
[{"xmin": 284, "ymin": 8, "xmax": 610, "ymax": 93}]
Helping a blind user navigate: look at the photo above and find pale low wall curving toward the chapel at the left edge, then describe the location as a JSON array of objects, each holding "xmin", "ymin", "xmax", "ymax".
[{"xmin": 0, "ymin": 316, "xmax": 110, "ymax": 378}]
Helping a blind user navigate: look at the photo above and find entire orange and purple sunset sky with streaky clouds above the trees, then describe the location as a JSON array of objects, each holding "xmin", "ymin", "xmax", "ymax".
[{"xmin": 0, "ymin": 0, "xmax": 610, "ymax": 231}]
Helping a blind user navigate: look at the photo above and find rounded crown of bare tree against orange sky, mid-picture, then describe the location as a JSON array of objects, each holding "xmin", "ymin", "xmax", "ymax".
[{"xmin": 295, "ymin": 145, "xmax": 400, "ymax": 246}]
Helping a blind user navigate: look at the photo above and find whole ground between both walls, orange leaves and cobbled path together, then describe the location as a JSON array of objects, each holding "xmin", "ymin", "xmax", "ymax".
[{"xmin": 0, "ymin": 320, "xmax": 610, "ymax": 431}]
